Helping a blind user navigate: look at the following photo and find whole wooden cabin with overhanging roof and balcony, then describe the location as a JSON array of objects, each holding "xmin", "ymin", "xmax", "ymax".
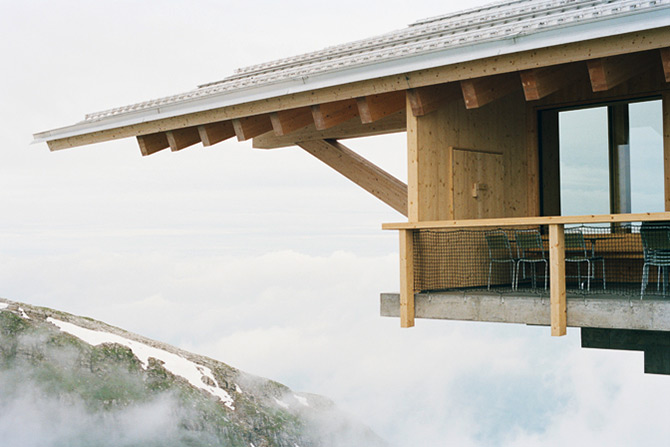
[{"xmin": 34, "ymin": 0, "xmax": 670, "ymax": 373}]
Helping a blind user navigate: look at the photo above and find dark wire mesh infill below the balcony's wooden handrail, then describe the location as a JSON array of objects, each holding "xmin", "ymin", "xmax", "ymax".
[{"xmin": 414, "ymin": 222, "xmax": 670, "ymax": 299}]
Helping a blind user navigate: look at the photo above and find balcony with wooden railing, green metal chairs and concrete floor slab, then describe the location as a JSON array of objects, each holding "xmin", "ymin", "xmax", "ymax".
[{"xmin": 381, "ymin": 213, "xmax": 670, "ymax": 336}]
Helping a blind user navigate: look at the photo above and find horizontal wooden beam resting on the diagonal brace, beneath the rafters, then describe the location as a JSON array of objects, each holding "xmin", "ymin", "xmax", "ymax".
[{"xmin": 253, "ymin": 110, "xmax": 406, "ymax": 149}]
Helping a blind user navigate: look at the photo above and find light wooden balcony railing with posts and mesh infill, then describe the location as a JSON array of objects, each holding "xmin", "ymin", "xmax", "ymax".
[{"xmin": 383, "ymin": 212, "xmax": 670, "ymax": 335}]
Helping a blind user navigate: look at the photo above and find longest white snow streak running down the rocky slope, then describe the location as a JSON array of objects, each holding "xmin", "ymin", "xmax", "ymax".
[{"xmin": 47, "ymin": 318, "xmax": 235, "ymax": 410}]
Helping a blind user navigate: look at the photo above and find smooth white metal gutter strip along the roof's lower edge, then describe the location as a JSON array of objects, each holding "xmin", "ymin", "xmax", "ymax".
[{"xmin": 33, "ymin": 9, "xmax": 670, "ymax": 143}]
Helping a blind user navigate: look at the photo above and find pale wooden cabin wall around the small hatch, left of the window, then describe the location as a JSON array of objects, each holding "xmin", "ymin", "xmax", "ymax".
[{"xmin": 407, "ymin": 91, "xmax": 529, "ymax": 221}]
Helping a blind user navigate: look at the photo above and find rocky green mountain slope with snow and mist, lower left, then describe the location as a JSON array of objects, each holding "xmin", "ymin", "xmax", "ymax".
[{"xmin": 0, "ymin": 299, "xmax": 385, "ymax": 447}]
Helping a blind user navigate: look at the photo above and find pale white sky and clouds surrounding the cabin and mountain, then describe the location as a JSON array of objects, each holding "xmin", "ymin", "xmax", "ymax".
[{"xmin": 0, "ymin": 0, "xmax": 670, "ymax": 446}]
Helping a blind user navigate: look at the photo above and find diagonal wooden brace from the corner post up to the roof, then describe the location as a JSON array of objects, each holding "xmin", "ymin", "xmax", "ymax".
[{"xmin": 298, "ymin": 140, "xmax": 407, "ymax": 216}]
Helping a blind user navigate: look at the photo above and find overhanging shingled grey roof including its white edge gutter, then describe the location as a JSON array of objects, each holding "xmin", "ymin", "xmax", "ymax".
[{"xmin": 34, "ymin": 0, "xmax": 670, "ymax": 148}]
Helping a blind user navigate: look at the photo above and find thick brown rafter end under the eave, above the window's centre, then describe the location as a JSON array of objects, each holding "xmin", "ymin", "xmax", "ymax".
[{"xmin": 586, "ymin": 53, "xmax": 652, "ymax": 92}]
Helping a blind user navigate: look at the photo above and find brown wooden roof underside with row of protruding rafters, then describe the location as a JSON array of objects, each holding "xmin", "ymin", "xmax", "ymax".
[{"xmin": 137, "ymin": 48, "xmax": 670, "ymax": 155}]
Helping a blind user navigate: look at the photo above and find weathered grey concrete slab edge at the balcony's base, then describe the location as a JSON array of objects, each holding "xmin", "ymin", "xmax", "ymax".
[{"xmin": 381, "ymin": 289, "xmax": 670, "ymax": 331}]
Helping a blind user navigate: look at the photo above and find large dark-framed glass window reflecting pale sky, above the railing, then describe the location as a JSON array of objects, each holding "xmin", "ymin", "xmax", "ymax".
[{"xmin": 540, "ymin": 100, "xmax": 665, "ymax": 216}]
